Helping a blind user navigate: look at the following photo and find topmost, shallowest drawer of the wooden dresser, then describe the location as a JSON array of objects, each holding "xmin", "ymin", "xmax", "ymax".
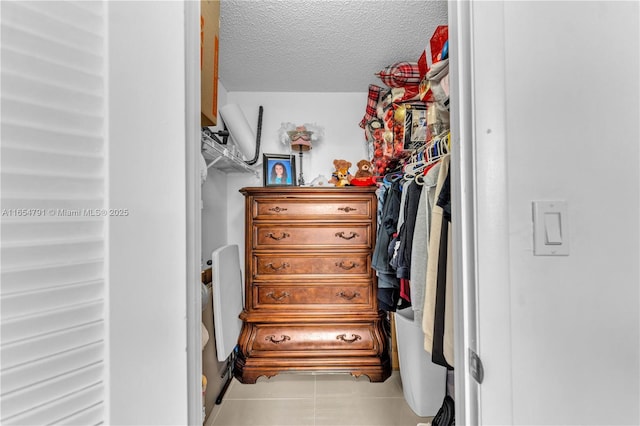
[{"xmin": 252, "ymin": 198, "xmax": 374, "ymax": 220}]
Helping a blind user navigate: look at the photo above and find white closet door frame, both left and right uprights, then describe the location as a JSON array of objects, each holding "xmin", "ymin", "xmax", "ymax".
[{"xmin": 183, "ymin": 0, "xmax": 513, "ymax": 424}]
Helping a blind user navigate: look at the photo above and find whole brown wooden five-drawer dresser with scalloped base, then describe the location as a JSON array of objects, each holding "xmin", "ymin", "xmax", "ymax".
[{"xmin": 235, "ymin": 187, "xmax": 391, "ymax": 383}]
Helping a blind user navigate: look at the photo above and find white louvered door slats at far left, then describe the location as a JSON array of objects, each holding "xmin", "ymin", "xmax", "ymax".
[{"xmin": 0, "ymin": 1, "xmax": 107, "ymax": 425}]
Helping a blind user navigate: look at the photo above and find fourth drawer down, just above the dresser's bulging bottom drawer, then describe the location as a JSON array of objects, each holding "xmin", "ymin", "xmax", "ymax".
[{"xmin": 253, "ymin": 282, "xmax": 373, "ymax": 311}]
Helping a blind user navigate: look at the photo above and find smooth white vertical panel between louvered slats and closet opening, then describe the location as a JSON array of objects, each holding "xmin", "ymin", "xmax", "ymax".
[{"xmin": 108, "ymin": 2, "xmax": 189, "ymax": 425}]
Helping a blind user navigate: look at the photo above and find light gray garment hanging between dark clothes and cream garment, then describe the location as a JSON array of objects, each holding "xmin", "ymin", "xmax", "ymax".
[{"xmin": 410, "ymin": 162, "xmax": 440, "ymax": 324}]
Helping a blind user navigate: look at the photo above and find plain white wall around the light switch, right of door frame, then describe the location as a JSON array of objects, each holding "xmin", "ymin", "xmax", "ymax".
[{"xmin": 473, "ymin": 2, "xmax": 640, "ymax": 425}]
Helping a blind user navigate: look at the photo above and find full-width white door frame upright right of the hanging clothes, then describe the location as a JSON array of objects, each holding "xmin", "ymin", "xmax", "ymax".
[{"xmin": 449, "ymin": 1, "xmax": 513, "ymax": 425}]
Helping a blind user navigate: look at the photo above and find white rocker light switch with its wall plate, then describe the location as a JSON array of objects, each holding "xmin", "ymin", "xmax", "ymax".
[{"xmin": 533, "ymin": 201, "xmax": 569, "ymax": 256}]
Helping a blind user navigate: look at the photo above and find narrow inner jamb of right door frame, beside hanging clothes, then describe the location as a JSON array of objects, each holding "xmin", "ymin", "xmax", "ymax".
[{"xmin": 448, "ymin": 2, "xmax": 479, "ymax": 424}]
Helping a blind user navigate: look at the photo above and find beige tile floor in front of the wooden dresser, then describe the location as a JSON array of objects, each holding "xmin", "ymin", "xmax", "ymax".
[{"xmin": 205, "ymin": 371, "xmax": 431, "ymax": 426}]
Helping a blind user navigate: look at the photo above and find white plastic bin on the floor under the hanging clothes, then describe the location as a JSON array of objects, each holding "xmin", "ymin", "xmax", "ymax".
[{"xmin": 395, "ymin": 308, "xmax": 447, "ymax": 417}]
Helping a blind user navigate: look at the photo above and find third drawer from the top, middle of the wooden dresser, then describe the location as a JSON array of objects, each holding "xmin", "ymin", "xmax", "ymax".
[{"xmin": 252, "ymin": 252, "xmax": 373, "ymax": 280}]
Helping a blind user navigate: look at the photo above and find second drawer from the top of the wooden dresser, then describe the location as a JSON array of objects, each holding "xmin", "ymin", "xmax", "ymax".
[{"xmin": 253, "ymin": 223, "xmax": 373, "ymax": 250}]
